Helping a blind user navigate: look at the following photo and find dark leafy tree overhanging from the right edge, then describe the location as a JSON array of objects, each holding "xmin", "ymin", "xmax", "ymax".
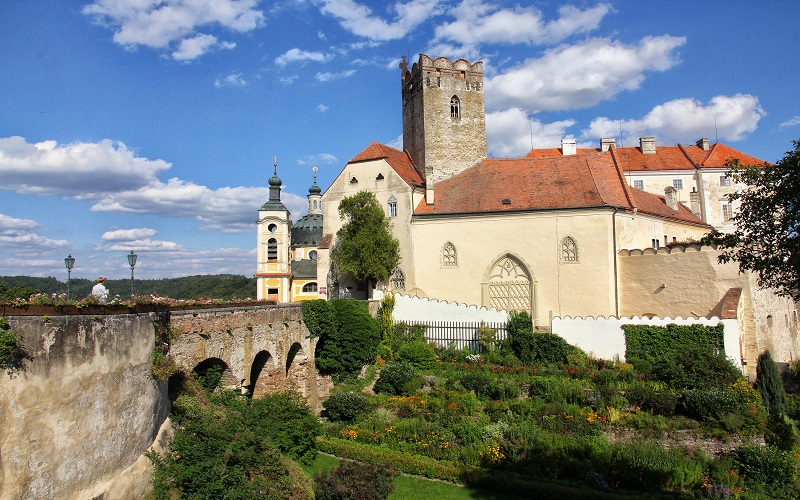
[{"xmin": 706, "ymin": 141, "xmax": 800, "ymax": 300}]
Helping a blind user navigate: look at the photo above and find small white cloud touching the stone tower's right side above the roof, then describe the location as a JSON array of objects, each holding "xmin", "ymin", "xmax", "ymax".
[{"xmin": 486, "ymin": 108, "xmax": 575, "ymax": 157}]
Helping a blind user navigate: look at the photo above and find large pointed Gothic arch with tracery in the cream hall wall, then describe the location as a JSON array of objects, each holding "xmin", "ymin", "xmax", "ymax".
[{"xmin": 481, "ymin": 253, "xmax": 536, "ymax": 319}]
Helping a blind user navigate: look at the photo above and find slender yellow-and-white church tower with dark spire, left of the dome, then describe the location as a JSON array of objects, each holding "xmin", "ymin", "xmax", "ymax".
[{"xmin": 256, "ymin": 158, "xmax": 292, "ymax": 302}]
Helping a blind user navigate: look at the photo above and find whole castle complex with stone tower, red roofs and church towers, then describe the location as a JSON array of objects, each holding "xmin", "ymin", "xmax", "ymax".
[{"xmin": 257, "ymin": 55, "xmax": 800, "ymax": 376}]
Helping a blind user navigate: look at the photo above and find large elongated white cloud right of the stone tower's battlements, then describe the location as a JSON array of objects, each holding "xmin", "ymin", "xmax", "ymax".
[{"xmin": 486, "ymin": 36, "xmax": 686, "ymax": 113}]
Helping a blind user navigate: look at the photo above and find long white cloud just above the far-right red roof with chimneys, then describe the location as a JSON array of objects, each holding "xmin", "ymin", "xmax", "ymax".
[{"xmin": 581, "ymin": 94, "xmax": 766, "ymax": 145}]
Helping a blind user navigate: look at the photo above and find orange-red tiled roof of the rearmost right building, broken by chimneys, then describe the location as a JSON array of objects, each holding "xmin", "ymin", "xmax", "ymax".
[{"xmin": 525, "ymin": 143, "xmax": 766, "ymax": 172}]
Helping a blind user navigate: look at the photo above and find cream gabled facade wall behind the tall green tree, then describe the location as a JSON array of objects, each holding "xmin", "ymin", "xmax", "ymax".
[{"xmin": 317, "ymin": 160, "xmax": 421, "ymax": 291}]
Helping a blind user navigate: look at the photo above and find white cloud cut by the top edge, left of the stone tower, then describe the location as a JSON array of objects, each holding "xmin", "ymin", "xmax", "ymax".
[{"xmin": 321, "ymin": 0, "xmax": 439, "ymax": 41}]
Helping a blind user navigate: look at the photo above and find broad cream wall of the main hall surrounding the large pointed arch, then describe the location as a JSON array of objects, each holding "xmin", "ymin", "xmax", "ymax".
[{"xmin": 412, "ymin": 210, "xmax": 616, "ymax": 326}]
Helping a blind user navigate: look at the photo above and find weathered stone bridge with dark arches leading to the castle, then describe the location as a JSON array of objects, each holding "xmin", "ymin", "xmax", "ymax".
[{"xmin": 169, "ymin": 304, "xmax": 319, "ymax": 405}]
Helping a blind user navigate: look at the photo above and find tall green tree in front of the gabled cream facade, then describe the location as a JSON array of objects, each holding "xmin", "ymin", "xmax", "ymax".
[{"xmin": 333, "ymin": 191, "xmax": 400, "ymax": 292}]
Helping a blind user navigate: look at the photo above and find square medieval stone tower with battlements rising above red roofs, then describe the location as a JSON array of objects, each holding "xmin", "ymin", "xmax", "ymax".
[{"xmin": 400, "ymin": 54, "xmax": 486, "ymax": 204}]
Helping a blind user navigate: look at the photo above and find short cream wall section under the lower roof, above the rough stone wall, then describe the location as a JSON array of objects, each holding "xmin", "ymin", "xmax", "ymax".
[{"xmin": 617, "ymin": 212, "xmax": 709, "ymax": 250}]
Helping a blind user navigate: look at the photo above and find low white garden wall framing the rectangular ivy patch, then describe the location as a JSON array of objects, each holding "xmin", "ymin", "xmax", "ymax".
[{"xmin": 552, "ymin": 316, "xmax": 742, "ymax": 370}]
